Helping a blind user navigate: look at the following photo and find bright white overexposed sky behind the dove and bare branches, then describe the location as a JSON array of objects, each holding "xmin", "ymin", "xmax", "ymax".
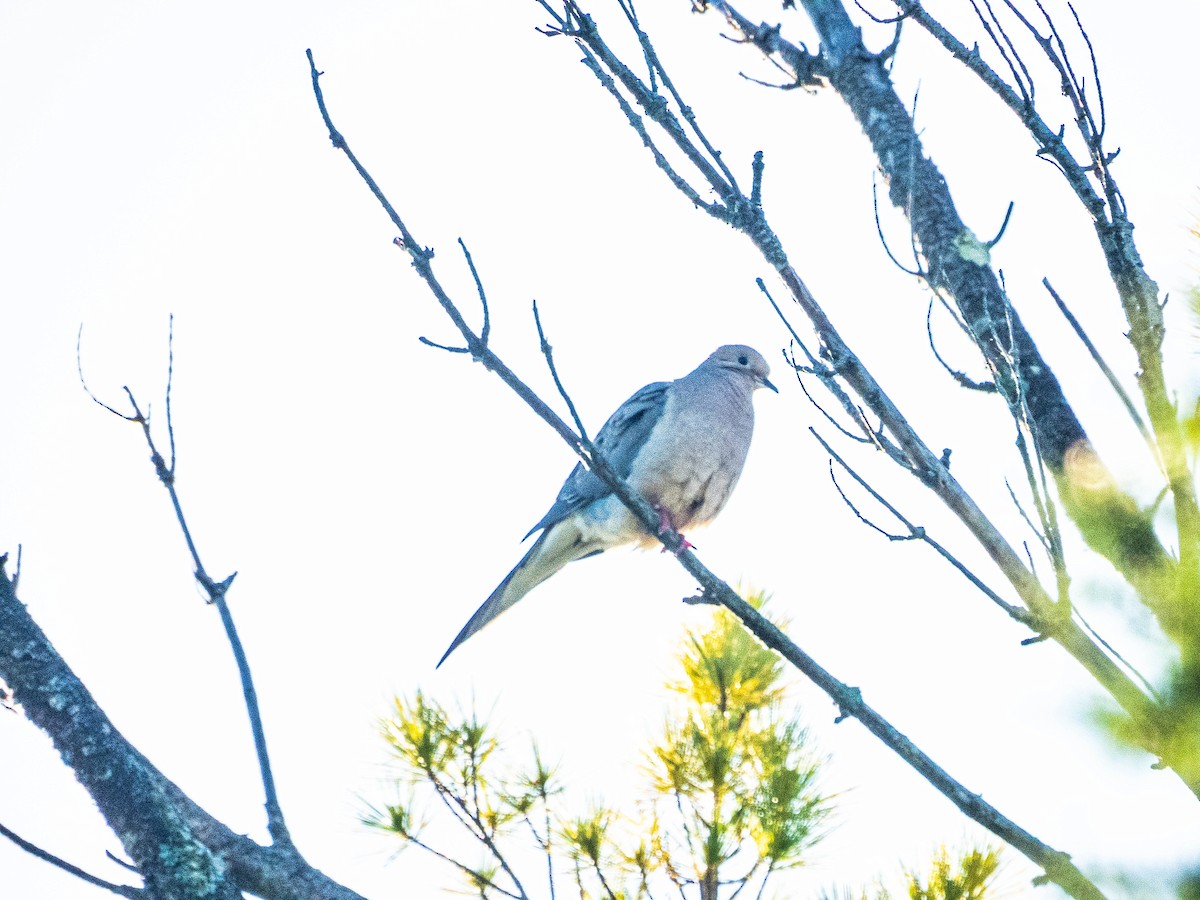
[{"xmin": 0, "ymin": 0, "xmax": 1200, "ymax": 900}]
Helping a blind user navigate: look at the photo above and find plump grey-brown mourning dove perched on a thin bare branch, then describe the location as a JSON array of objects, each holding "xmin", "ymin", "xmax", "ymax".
[{"xmin": 438, "ymin": 344, "xmax": 779, "ymax": 666}]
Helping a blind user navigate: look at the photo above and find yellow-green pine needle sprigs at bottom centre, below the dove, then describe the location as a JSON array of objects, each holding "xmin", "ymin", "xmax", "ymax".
[{"xmin": 364, "ymin": 596, "xmax": 829, "ymax": 900}]
